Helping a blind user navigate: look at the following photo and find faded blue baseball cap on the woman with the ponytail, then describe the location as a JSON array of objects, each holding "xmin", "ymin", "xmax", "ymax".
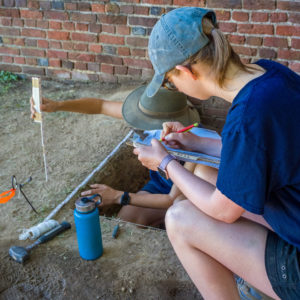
[{"xmin": 146, "ymin": 7, "xmax": 217, "ymax": 97}]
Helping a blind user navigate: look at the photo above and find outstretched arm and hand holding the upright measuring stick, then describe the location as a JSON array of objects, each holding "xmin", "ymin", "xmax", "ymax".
[{"xmin": 30, "ymin": 97, "xmax": 123, "ymax": 119}]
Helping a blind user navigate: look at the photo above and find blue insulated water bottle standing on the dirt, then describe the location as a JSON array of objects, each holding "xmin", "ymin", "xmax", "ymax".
[{"xmin": 74, "ymin": 194, "xmax": 103, "ymax": 260}]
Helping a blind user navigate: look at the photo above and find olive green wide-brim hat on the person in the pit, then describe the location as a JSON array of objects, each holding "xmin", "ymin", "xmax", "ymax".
[{"xmin": 122, "ymin": 85, "xmax": 200, "ymax": 130}]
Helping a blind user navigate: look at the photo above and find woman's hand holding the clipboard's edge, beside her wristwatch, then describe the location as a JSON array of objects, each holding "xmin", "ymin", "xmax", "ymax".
[{"xmin": 133, "ymin": 139, "xmax": 168, "ymax": 171}]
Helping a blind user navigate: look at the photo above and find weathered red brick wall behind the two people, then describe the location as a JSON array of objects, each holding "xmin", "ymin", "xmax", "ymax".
[{"xmin": 0, "ymin": 0, "xmax": 300, "ymax": 128}]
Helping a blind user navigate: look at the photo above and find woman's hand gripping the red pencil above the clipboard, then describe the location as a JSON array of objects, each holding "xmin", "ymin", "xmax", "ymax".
[{"xmin": 161, "ymin": 122, "xmax": 201, "ymax": 151}]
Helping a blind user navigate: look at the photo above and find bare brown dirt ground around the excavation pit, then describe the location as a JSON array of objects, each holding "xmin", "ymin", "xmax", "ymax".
[{"xmin": 0, "ymin": 81, "xmax": 201, "ymax": 299}]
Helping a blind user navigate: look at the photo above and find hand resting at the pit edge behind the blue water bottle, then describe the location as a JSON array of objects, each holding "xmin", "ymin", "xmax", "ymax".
[{"xmin": 81, "ymin": 184, "xmax": 123, "ymax": 206}]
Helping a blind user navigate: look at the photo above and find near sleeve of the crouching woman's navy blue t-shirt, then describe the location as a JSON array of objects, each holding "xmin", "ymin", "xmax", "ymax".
[{"xmin": 217, "ymin": 131, "xmax": 268, "ymax": 214}]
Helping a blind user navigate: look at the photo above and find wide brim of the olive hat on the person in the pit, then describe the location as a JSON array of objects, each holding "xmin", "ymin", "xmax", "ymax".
[{"xmin": 122, "ymin": 86, "xmax": 200, "ymax": 130}]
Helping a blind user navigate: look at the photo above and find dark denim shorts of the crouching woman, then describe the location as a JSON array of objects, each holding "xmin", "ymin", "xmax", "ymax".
[{"xmin": 265, "ymin": 231, "xmax": 300, "ymax": 300}]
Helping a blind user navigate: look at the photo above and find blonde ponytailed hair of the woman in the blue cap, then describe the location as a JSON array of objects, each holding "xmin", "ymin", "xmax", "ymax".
[{"xmin": 167, "ymin": 18, "xmax": 252, "ymax": 87}]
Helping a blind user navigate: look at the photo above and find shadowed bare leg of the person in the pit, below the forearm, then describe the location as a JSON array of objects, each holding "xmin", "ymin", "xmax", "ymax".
[{"xmin": 118, "ymin": 191, "xmax": 166, "ymax": 227}]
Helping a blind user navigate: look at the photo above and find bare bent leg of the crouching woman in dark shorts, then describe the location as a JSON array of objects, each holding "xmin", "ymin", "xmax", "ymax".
[{"xmin": 166, "ymin": 200, "xmax": 278, "ymax": 300}]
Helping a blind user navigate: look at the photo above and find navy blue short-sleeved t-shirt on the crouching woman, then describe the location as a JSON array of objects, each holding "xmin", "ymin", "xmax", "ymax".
[{"xmin": 217, "ymin": 60, "xmax": 300, "ymax": 250}]
